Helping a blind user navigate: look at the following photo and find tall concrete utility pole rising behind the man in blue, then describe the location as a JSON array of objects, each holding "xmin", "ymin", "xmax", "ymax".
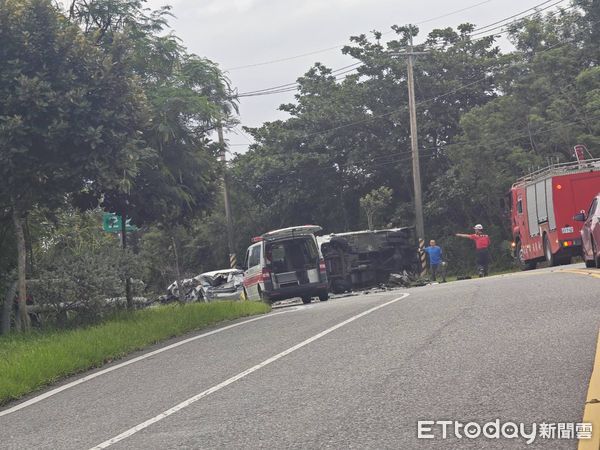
[{"xmin": 406, "ymin": 36, "xmax": 425, "ymax": 240}]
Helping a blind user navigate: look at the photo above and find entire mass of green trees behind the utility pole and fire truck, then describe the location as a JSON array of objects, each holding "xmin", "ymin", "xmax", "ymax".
[{"xmin": 233, "ymin": 0, "xmax": 600, "ymax": 271}]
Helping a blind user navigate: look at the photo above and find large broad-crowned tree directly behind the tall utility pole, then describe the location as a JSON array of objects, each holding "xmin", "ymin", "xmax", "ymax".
[{"xmin": 234, "ymin": 25, "xmax": 501, "ymax": 237}]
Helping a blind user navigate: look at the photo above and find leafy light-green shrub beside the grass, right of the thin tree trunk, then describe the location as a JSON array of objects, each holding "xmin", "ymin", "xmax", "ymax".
[{"xmin": 19, "ymin": 208, "xmax": 144, "ymax": 326}]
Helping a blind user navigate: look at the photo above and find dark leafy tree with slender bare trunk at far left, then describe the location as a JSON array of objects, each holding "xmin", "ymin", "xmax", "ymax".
[{"xmin": 0, "ymin": 0, "xmax": 145, "ymax": 326}]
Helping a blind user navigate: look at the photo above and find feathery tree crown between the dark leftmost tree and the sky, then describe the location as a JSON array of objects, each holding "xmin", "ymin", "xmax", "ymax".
[{"xmin": 69, "ymin": 0, "xmax": 236, "ymax": 227}]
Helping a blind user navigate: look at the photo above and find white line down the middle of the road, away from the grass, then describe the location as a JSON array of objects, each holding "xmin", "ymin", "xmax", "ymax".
[{"xmin": 91, "ymin": 292, "xmax": 410, "ymax": 450}]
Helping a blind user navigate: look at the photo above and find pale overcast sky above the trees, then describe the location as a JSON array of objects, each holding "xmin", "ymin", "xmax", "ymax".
[{"xmin": 143, "ymin": 0, "xmax": 567, "ymax": 152}]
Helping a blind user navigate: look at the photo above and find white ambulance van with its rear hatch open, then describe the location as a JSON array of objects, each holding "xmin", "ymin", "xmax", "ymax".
[{"xmin": 244, "ymin": 225, "xmax": 329, "ymax": 303}]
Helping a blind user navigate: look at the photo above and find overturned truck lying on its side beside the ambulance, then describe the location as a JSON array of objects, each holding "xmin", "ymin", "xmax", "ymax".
[{"xmin": 317, "ymin": 227, "xmax": 418, "ymax": 294}]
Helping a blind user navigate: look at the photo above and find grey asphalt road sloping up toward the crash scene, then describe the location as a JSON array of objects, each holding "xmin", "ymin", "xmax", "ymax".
[{"xmin": 0, "ymin": 266, "xmax": 600, "ymax": 449}]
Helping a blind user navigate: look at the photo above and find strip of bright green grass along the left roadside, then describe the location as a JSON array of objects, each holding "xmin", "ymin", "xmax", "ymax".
[{"xmin": 0, "ymin": 302, "xmax": 270, "ymax": 405}]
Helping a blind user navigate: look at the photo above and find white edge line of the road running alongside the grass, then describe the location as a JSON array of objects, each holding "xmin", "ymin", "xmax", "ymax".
[{"xmin": 0, "ymin": 310, "xmax": 293, "ymax": 417}]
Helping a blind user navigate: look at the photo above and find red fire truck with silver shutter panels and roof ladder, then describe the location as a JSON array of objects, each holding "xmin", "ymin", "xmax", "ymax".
[{"xmin": 510, "ymin": 158, "xmax": 600, "ymax": 270}]
